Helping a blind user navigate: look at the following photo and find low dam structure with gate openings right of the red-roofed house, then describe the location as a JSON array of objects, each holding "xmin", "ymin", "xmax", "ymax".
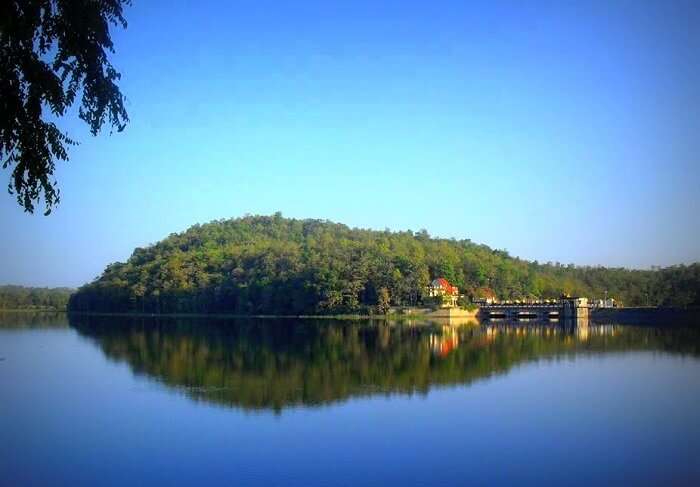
[{"xmin": 479, "ymin": 298, "xmax": 590, "ymax": 320}]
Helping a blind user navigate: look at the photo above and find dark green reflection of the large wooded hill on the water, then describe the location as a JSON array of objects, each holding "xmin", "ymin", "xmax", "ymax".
[{"xmin": 71, "ymin": 316, "xmax": 700, "ymax": 410}]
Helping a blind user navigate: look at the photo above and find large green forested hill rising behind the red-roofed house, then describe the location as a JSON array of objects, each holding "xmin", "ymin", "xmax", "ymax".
[{"xmin": 69, "ymin": 214, "xmax": 700, "ymax": 315}]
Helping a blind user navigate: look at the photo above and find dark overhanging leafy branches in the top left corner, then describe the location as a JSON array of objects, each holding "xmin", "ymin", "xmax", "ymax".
[{"xmin": 0, "ymin": 0, "xmax": 131, "ymax": 215}]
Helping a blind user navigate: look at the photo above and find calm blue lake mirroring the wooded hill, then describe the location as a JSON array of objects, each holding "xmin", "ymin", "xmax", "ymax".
[{"xmin": 0, "ymin": 313, "xmax": 700, "ymax": 486}]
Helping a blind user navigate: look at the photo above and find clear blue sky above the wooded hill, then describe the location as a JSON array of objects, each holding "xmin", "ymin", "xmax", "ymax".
[{"xmin": 0, "ymin": 0, "xmax": 700, "ymax": 286}]
